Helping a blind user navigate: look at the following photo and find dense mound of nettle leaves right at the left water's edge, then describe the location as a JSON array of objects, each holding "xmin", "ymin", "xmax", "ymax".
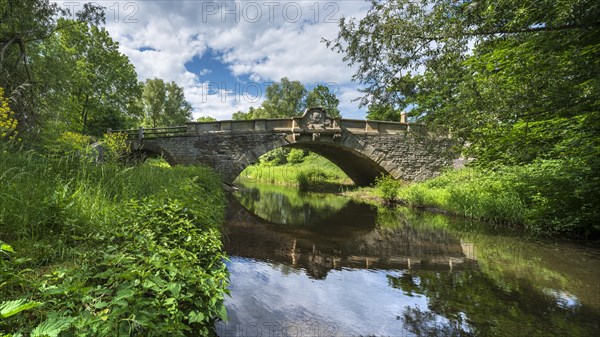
[{"xmin": 54, "ymin": 199, "xmax": 228, "ymax": 336}]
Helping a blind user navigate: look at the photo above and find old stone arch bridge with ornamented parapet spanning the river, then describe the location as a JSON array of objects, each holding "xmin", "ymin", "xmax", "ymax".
[{"xmin": 109, "ymin": 108, "xmax": 455, "ymax": 185}]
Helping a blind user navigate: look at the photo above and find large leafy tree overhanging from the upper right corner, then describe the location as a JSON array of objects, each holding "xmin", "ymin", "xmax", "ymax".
[{"xmin": 326, "ymin": 0, "xmax": 600, "ymax": 162}]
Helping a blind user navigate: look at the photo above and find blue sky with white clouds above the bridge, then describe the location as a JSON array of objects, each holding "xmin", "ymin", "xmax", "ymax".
[{"xmin": 95, "ymin": 0, "xmax": 370, "ymax": 119}]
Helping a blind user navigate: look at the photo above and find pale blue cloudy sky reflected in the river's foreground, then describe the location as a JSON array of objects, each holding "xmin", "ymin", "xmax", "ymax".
[{"xmin": 217, "ymin": 257, "xmax": 436, "ymax": 336}]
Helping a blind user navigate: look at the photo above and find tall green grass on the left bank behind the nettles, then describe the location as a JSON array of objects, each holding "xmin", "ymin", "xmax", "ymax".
[{"xmin": 0, "ymin": 151, "xmax": 223, "ymax": 239}]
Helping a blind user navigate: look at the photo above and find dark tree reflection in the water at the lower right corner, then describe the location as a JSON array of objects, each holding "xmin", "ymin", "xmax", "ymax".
[{"xmin": 388, "ymin": 266, "xmax": 600, "ymax": 337}]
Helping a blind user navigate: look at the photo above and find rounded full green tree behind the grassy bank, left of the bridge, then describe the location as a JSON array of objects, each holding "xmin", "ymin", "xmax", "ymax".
[{"xmin": 31, "ymin": 19, "xmax": 140, "ymax": 135}]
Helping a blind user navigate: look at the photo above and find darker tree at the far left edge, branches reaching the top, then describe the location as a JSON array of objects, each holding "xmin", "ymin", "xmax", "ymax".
[{"xmin": 0, "ymin": 0, "xmax": 104, "ymax": 136}]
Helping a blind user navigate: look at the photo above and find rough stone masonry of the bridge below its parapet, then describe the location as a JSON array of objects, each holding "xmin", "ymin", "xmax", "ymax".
[{"xmin": 133, "ymin": 130, "xmax": 455, "ymax": 185}]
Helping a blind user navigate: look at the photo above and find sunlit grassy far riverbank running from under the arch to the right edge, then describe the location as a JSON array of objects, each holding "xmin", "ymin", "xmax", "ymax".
[{"xmin": 242, "ymin": 154, "xmax": 600, "ymax": 239}]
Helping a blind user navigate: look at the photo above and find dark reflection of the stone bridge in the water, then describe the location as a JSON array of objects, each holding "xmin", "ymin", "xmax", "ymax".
[{"xmin": 225, "ymin": 200, "xmax": 471, "ymax": 279}]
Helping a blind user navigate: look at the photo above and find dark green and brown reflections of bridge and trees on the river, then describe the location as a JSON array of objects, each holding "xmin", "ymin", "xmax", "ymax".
[{"xmin": 226, "ymin": 185, "xmax": 600, "ymax": 337}]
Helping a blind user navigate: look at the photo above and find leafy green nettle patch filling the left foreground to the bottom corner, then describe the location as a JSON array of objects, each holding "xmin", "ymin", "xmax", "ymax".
[{"xmin": 0, "ymin": 198, "xmax": 229, "ymax": 337}]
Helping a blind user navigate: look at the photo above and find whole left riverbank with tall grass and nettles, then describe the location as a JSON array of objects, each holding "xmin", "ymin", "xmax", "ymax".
[{"xmin": 0, "ymin": 149, "xmax": 228, "ymax": 336}]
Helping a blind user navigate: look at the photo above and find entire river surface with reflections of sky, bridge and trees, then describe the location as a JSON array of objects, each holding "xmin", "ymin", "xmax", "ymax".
[{"xmin": 216, "ymin": 185, "xmax": 600, "ymax": 337}]
